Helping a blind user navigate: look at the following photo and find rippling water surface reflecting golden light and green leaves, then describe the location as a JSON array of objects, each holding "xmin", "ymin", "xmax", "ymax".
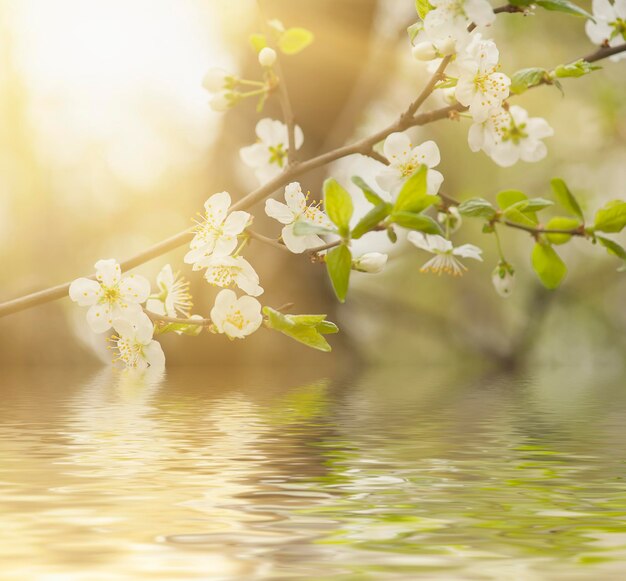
[{"xmin": 0, "ymin": 368, "xmax": 626, "ymax": 581}]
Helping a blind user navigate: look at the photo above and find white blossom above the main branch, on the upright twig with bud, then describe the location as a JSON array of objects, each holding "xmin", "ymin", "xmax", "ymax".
[{"xmin": 239, "ymin": 118, "xmax": 304, "ymax": 183}]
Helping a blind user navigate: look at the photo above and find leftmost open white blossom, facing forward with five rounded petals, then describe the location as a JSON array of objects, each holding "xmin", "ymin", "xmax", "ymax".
[{"xmin": 69, "ymin": 258, "xmax": 150, "ymax": 333}]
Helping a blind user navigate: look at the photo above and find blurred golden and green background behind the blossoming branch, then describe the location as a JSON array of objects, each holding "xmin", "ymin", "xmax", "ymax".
[{"xmin": 0, "ymin": 0, "xmax": 626, "ymax": 369}]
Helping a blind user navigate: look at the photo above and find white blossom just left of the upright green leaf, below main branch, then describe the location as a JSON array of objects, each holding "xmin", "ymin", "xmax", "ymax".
[{"xmin": 265, "ymin": 182, "xmax": 333, "ymax": 254}]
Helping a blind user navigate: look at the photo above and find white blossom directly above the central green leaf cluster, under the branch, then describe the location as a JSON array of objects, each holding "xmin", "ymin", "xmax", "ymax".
[{"xmin": 376, "ymin": 133, "xmax": 443, "ymax": 195}]
